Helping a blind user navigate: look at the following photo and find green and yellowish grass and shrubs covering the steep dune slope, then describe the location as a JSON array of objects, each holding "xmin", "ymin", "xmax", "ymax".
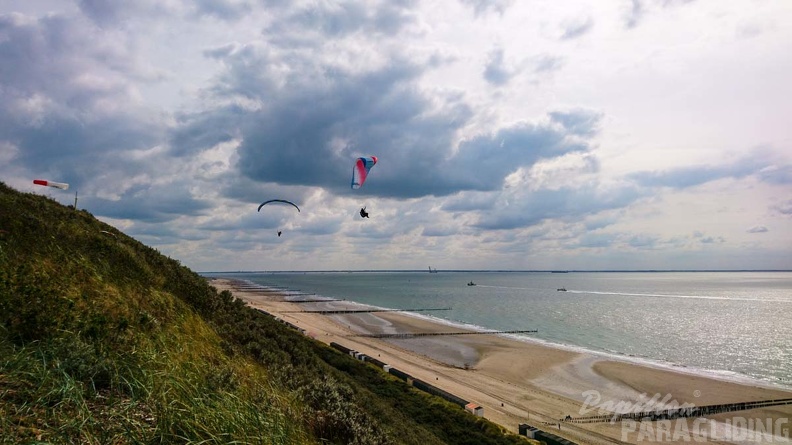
[{"xmin": 0, "ymin": 183, "xmax": 523, "ymax": 445}]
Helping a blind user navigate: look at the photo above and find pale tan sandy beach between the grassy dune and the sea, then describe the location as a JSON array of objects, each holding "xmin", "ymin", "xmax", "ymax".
[{"xmin": 211, "ymin": 279, "xmax": 792, "ymax": 444}]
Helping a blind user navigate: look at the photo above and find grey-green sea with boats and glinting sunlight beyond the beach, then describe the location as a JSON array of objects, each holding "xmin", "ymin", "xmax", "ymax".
[{"xmin": 206, "ymin": 271, "xmax": 792, "ymax": 388}]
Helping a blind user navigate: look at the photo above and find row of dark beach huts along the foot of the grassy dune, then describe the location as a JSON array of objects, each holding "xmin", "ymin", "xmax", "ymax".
[{"xmin": 257, "ymin": 309, "xmax": 575, "ymax": 445}]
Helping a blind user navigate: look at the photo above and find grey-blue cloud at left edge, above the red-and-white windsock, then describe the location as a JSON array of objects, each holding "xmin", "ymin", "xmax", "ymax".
[{"xmin": 0, "ymin": 14, "xmax": 165, "ymax": 188}]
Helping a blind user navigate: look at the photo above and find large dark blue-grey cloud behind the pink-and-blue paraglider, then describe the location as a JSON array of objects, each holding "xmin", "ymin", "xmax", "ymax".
[{"xmin": 187, "ymin": 36, "xmax": 600, "ymax": 198}]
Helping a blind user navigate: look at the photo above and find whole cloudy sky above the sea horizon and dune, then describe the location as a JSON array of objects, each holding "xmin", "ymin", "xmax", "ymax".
[{"xmin": 0, "ymin": 0, "xmax": 792, "ymax": 271}]
